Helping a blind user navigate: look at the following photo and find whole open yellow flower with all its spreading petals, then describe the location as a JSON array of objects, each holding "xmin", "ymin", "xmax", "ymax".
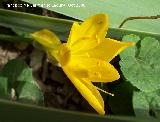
[{"xmin": 32, "ymin": 14, "xmax": 133, "ymax": 115}]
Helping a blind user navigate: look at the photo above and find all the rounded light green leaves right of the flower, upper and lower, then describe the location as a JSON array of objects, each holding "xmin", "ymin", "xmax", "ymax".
[{"xmin": 120, "ymin": 35, "xmax": 160, "ymax": 117}]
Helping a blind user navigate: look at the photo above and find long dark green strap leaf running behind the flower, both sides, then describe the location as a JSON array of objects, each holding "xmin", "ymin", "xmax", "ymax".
[{"xmin": 0, "ymin": 9, "xmax": 160, "ymax": 42}]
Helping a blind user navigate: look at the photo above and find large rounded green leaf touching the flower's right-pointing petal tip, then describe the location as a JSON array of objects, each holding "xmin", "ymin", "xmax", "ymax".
[{"xmin": 120, "ymin": 36, "xmax": 160, "ymax": 92}]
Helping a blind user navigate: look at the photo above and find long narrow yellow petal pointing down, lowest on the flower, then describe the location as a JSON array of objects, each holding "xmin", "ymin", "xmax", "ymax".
[{"xmin": 62, "ymin": 67, "xmax": 105, "ymax": 115}]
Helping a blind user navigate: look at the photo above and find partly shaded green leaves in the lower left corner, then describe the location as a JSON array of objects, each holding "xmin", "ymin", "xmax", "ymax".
[{"xmin": 0, "ymin": 59, "xmax": 43, "ymax": 104}]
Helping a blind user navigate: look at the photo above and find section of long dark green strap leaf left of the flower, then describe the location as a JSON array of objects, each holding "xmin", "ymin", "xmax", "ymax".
[{"xmin": 0, "ymin": 9, "xmax": 72, "ymax": 40}]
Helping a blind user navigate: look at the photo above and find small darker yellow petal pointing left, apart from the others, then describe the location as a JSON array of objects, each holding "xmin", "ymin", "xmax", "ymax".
[{"xmin": 32, "ymin": 29, "xmax": 61, "ymax": 49}]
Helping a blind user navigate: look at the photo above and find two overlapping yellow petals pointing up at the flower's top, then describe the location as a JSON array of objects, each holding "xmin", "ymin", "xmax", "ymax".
[{"xmin": 67, "ymin": 14, "xmax": 108, "ymax": 47}]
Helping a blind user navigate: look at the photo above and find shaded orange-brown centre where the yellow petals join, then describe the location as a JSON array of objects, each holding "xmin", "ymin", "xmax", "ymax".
[{"xmin": 59, "ymin": 43, "xmax": 70, "ymax": 66}]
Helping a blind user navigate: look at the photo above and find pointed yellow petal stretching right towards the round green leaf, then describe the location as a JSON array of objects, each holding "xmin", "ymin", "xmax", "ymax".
[{"xmin": 75, "ymin": 38, "xmax": 134, "ymax": 62}]
